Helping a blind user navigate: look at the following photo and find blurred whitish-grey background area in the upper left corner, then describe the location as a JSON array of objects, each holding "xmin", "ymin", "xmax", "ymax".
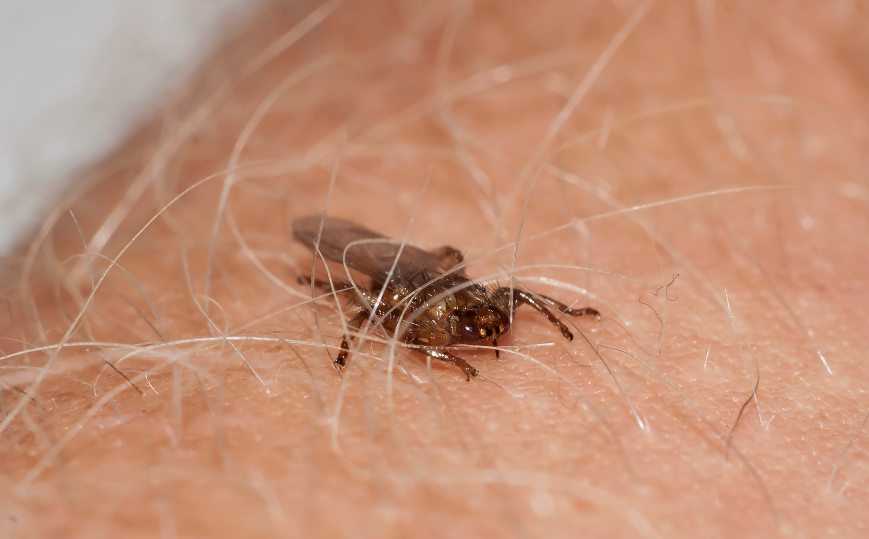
[{"xmin": 0, "ymin": 0, "xmax": 262, "ymax": 253}]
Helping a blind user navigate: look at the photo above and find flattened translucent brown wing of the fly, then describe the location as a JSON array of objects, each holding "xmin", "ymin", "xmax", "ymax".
[{"xmin": 293, "ymin": 215, "xmax": 443, "ymax": 285}]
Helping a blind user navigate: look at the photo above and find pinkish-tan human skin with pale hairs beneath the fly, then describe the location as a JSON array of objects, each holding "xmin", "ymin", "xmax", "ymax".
[{"xmin": 0, "ymin": 0, "xmax": 869, "ymax": 538}]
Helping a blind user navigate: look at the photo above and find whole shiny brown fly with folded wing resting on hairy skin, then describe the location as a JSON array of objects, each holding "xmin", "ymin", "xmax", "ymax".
[{"xmin": 292, "ymin": 215, "xmax": 600, "ymax": 381}]
